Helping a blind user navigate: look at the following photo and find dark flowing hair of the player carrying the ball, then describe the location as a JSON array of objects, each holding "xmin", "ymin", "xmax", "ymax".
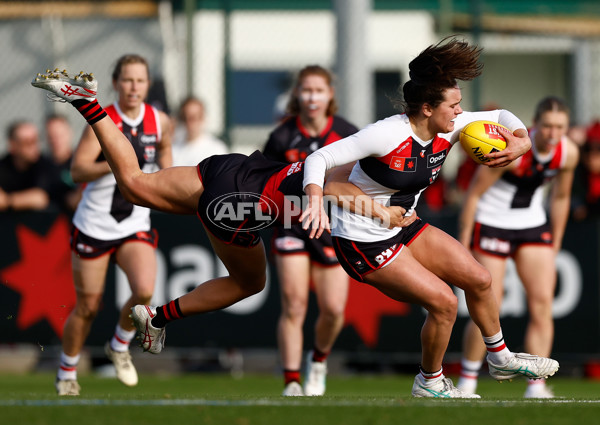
[{"xmin": 394, "ymin": 36, "xmax": 483, "ymax": 116}]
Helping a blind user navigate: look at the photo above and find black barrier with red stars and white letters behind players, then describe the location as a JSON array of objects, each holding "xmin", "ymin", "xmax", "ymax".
[{"xmin": 0, "ymin": 212, "xmax": 600, "ymax": 358}]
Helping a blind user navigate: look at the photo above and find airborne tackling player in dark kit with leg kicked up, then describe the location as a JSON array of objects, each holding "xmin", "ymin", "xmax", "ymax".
[{"xmin": 32, "ymin": 71, "xmax": 415, "ymax": 344}]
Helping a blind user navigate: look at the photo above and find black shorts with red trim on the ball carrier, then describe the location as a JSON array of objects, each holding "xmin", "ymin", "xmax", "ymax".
[{"xmin": 333, "ymin": 218, "xmax": 429, "ymax": 282}]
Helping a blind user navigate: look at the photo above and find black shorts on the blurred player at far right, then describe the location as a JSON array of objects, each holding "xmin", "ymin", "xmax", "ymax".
[{"xmin": 471, "ymin": 223, "xmax": 553, "ymax": 258}]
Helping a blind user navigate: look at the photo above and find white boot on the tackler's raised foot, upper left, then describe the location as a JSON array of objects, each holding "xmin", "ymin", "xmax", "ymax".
[{"xmin": 31, "ymin": 68, "xmax": 98, "ymax": 103}]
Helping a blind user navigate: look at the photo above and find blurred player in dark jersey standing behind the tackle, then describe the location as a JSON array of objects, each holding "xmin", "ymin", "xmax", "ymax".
[{"xmin": 263, "ymin": 65, "xmax": 358, "ymax": 396}]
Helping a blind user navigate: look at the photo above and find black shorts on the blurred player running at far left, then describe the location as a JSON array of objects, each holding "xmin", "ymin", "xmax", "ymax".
[{"xmin": 71, "ymin": 226, "xmax": 158, "ymax": 259}]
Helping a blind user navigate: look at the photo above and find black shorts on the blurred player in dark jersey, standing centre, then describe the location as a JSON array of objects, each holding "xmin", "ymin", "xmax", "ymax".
[{"xmin": 271, "ymin": 224, "xmax": 339, "ymax": 267}]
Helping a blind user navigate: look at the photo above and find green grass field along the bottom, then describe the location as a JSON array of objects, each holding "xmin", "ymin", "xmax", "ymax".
[{"xmin": 0, "ymin": 374, "xmax": 600, "ymax": 425}]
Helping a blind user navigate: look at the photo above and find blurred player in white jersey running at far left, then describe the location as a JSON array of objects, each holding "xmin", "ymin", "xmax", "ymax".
[{"xmin": 56, "ymin": 55, "xmax": 171, "ymax": 395}]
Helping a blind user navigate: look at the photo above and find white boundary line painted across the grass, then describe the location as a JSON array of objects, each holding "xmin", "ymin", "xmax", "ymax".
[{"xmin": 0, "ymin": 398, "xmax": 600, "ymax": 407}]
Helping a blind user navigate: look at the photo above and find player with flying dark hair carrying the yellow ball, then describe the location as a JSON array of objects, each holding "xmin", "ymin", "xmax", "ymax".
[{"xmin": 303, "ymin": 38, "xmax": 558, "ymax": 398}]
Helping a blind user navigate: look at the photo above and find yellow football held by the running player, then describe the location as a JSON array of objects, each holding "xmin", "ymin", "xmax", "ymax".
[{"xmin": 460, "ymin": 121, "xmax": 508, "ymax": 164}]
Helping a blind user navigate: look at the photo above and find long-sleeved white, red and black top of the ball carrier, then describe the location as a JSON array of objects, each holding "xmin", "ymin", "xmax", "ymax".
[{"xmin": 304, "ymin": 110, "xmax": 525, "ymax": 242}]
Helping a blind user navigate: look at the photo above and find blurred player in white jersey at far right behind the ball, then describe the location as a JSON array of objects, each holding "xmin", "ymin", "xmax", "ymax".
[{"xmin": 458, "ymin": 97, "xmax": 579, "ymax": 398}]
